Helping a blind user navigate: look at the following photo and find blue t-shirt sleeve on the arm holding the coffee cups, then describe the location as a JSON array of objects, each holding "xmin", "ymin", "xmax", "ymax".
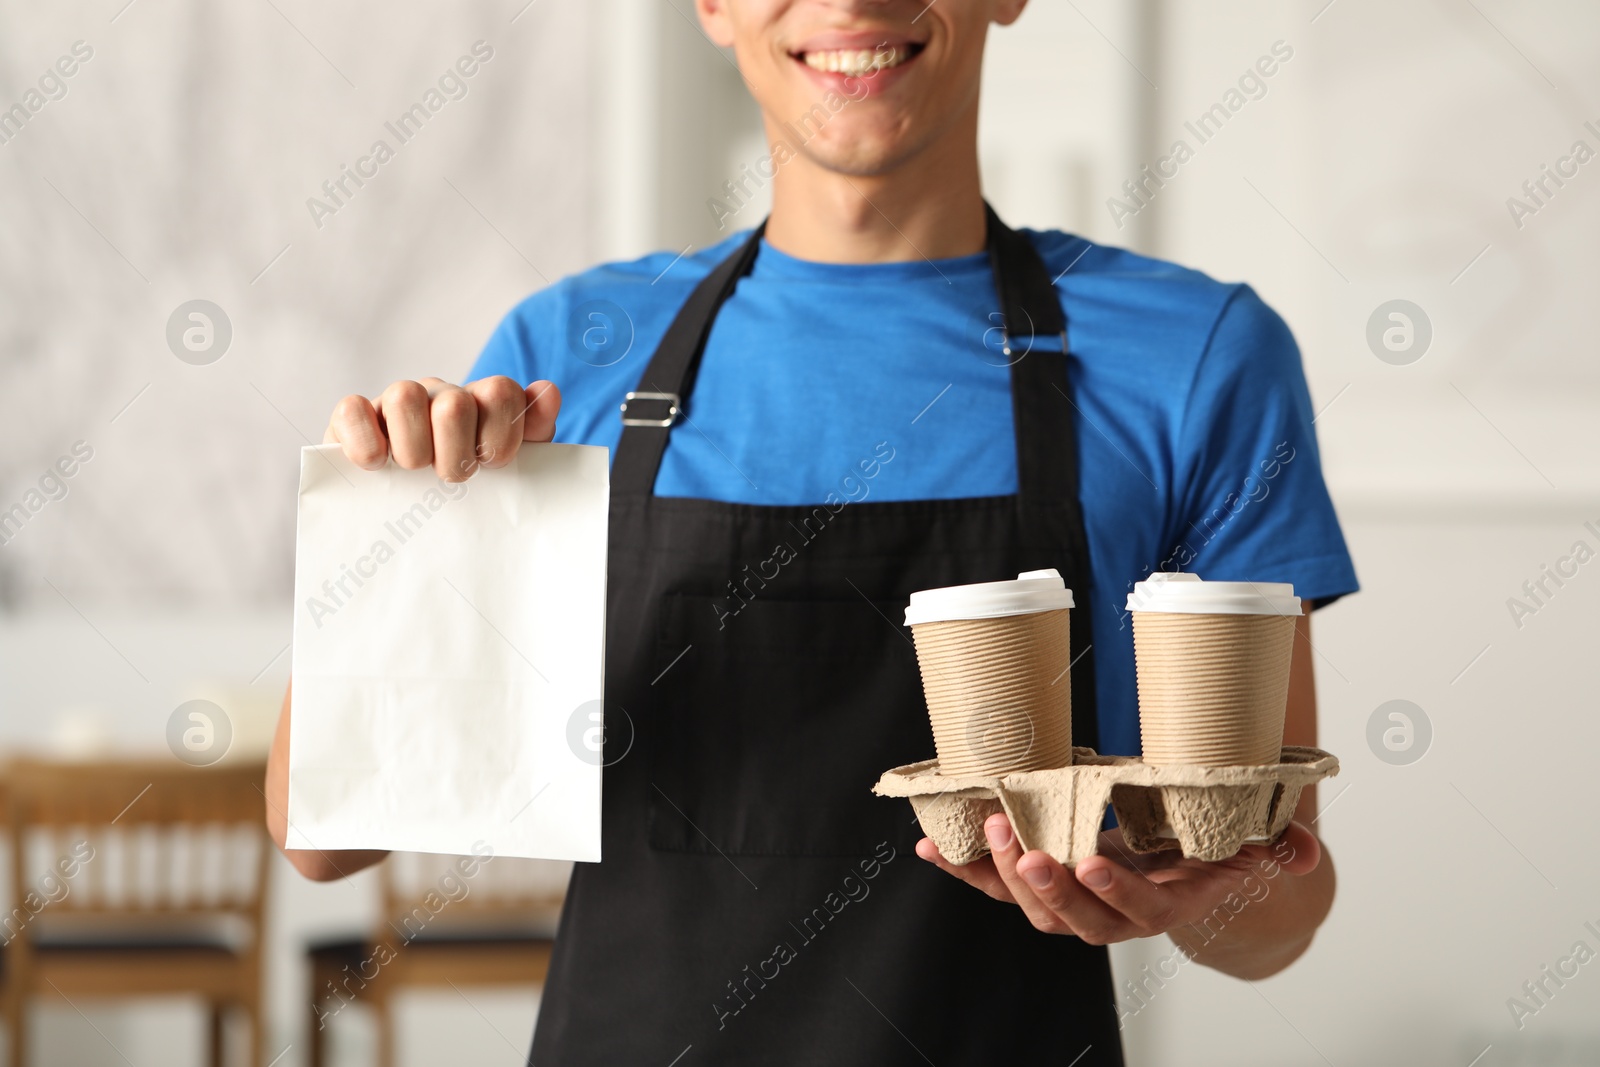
[{"xmin": 1173, "ymin": 286, "xmax": 1358, "ymax": 606}]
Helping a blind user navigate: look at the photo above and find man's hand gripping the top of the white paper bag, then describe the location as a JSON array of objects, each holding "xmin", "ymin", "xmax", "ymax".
[{"xmin": 323, "ymin": 376, "xmax": 562, "ymax": 482}]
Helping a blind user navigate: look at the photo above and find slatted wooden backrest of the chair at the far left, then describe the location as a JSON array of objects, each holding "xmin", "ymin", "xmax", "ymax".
[{"xmin": 0, "ymin": 760, "xmax": 270, "ymax": 944}]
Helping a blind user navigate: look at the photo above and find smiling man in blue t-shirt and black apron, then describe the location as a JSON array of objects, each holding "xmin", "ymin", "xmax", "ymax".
[{"xmin": 259, "ymin": 0, "xmax": 1355, "ymax": 1067}]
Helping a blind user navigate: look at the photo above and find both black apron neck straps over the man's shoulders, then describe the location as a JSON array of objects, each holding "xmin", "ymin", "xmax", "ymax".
[{"xmin": 611, "ymin": 202, "xmax": 1077, "ymax": 506}]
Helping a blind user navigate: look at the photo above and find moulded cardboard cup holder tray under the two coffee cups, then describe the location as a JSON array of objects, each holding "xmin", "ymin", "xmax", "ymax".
[{"xmin": 872, "ymin": 745, "xmax": 1339, "ymax": 867}]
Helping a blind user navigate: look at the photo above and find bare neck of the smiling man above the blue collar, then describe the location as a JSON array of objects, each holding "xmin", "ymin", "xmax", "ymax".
[{"xmin": 766, "ymin": 102, "xmax": 986, "ymax": 262}]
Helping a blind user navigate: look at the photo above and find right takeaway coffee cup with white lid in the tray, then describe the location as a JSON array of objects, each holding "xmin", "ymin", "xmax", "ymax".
[{"xmin": 1128, "ymin": 573, "xmax": 1301, "ymax": 766}]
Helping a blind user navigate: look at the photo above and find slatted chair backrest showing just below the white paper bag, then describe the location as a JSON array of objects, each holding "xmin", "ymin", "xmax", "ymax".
[{"xmin": 379, "ymin": 851, "xmax": 573, "ymax": 941}]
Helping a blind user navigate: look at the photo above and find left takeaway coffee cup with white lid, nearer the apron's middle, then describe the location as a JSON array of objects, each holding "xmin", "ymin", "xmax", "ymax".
[{"xmin": 906, "ymin": 571, "xmax": 1072, "ymax": 776}]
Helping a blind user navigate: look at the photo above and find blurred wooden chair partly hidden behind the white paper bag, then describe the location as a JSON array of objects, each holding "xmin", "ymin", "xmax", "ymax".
[{"xmin": 307, "ymin": 853, "xmax": 566, "ymax": 1067}]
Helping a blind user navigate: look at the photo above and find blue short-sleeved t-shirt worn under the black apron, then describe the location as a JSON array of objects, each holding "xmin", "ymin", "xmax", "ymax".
[{"xmin": 469, "ymin": 230, "xmax": 1357, "ymax": 755}]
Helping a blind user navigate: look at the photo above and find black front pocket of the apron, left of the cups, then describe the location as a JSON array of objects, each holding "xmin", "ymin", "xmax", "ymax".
[{"xmin": 643, "ymin": 595, "xmax": 933, "ymax": 856}]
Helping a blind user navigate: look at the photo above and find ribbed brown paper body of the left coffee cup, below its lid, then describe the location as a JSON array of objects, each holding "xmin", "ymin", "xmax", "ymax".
[{"xmin": 912, "ymin": 609, "xmax": 1072, "ymax": 776}]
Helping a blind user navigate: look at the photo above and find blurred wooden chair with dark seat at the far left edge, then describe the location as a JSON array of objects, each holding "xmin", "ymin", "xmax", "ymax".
[{"xmin": 0, "ymin": 760, "xmax": 270, "ymax": 1067}]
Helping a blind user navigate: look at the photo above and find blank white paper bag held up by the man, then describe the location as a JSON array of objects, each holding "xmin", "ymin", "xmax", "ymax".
[{"xmin": 288, "ymin": 445, "xmax": 610, "ymax": 861}]
